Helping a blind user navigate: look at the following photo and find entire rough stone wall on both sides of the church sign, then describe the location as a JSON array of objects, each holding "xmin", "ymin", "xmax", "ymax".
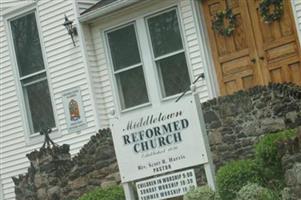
[{"xmin": 13, "ymin": 84, "xmax": 301, "ymax": 200}]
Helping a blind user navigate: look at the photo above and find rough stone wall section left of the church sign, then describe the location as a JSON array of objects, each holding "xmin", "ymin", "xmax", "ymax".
[{"xmin": 13, "ymin": 129, "xmax": 120, "ymax": 200}]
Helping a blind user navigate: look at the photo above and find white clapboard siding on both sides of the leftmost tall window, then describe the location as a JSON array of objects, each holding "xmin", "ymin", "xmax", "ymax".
[{"xmin": 0, "ymin": 0, "xmax": 96, "ymax": 200}]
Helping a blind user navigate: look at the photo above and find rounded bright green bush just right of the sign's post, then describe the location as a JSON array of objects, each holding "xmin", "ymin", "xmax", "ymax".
[{"xmin": 216, "ymin": 160, "xmax": 262, "ymax": 200}]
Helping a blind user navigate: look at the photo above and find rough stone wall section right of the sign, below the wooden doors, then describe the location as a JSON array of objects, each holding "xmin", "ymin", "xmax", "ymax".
[{"xmin": 202, "ymin": 84, "xmax": 301, "ymax": 168}]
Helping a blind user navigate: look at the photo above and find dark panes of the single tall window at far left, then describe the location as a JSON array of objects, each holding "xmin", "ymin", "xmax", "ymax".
[{"xmin": 10, "ymin": 12, "xmax": 55, "ymax": 134}]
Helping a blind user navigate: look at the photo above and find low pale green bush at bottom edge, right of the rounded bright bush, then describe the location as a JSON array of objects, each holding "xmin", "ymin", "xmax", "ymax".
[{"xmin": 236, "ymin": 183, "xmax": 279, "ymax": 200}]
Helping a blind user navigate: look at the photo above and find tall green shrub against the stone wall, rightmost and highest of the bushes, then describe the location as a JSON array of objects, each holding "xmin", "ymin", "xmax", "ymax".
[{"xmin": 255, "ymin": 130, "xmax": 296, "ymax": 186}]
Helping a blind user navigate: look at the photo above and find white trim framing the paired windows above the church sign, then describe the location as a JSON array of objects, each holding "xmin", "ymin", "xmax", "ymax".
[{"xmin": 100, "ymin": 1, "xmax": 193, "ymax": 114}]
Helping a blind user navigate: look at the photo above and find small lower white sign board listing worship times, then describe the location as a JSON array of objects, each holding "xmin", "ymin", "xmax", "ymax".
[{"xmin": 136, "ymin": 169, "xmax": 197, "ymax": 200}]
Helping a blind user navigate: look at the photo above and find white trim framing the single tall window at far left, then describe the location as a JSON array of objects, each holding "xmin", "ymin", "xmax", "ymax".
[{"xmin": 3, "ymin": 2, "xmax": 62, "ymax": 145}]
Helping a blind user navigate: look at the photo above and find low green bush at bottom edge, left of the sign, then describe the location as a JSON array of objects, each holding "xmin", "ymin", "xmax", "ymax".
[{"xmin": 79, "ymin": 186, "xmax": 125, "ymax": 200}]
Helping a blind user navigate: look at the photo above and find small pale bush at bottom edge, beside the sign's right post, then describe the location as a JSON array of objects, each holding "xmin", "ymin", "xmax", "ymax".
[{"xmin": 184, "ymin": 186, "xmax": 220, "ymax": 200}]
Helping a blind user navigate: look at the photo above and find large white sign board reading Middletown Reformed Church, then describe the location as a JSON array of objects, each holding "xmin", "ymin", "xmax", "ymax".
[{"xmin": 111, "ymin": 95, "xmax": 208, "ymax": 183}]
